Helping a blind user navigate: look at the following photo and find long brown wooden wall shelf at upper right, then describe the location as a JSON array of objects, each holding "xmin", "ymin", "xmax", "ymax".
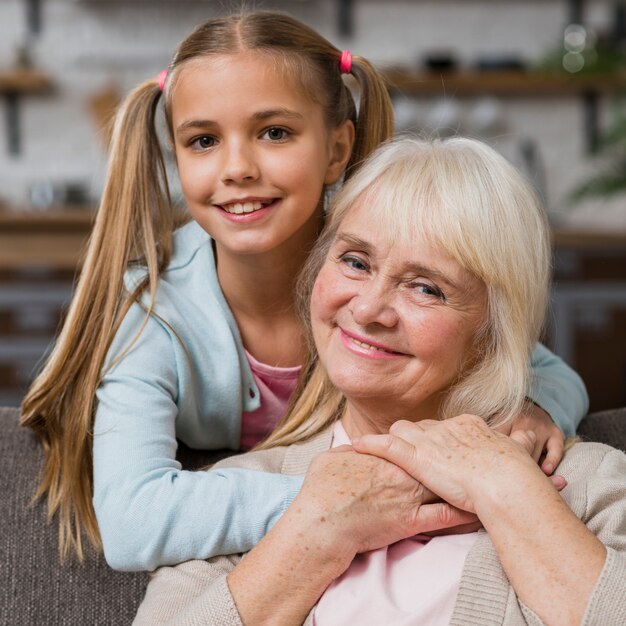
[{"xmin": 384, "ymin": 69, "xmax": 626, "ymax": 97}]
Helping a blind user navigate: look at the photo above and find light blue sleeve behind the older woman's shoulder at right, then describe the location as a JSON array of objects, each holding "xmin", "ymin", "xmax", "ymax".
[{"xmin": 529, "ymin": 343, "xmax": 589, "ymax": 436}]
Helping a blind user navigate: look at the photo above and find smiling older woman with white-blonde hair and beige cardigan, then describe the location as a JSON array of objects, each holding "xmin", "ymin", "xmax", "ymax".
[{"xmin": 136, "ymin": 139, "xmax": 626, "ymax": 626}]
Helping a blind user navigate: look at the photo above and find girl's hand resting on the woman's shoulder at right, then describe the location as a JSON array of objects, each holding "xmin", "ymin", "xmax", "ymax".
[{"xmin": 495, "ymin": 402, "xmax": 565, "ymax": 476}]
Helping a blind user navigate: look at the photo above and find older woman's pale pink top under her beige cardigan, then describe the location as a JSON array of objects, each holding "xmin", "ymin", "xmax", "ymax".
[{"xmin": 314, "ymin": 422, "xmax": 477, "ymax": 626}]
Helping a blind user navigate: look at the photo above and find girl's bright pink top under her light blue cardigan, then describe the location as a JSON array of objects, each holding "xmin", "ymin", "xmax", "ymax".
[{"xmin": 239, "ymin": 351, "xmax": 301, "ymax": 450}]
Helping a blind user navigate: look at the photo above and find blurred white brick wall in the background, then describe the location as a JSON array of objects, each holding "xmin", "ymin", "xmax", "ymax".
[{"xmin": 0, "ymin": 0, "xmax": 626, "ymax": 229}]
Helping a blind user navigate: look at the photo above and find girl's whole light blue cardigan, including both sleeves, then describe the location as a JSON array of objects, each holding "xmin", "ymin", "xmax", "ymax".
[{"xmin": 93, "ymin": 222, "xmax": 587, "ymax": 570}]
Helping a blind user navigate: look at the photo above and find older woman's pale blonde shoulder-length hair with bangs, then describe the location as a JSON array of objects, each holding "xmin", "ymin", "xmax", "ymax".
[{"xmin": 260, "ymin": 138, "xmax": 550, "ymax": 448}]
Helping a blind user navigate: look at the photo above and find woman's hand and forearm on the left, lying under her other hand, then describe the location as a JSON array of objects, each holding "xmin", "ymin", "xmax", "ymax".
[{"xmin": 228, "ymin": 446, "xmax": 476, "ymax": 626}]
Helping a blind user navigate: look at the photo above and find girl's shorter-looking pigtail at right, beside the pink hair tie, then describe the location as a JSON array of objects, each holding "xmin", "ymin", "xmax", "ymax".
[{"xmin": 345, "ymin": 56, "xmax": 393, "ymax": 180}]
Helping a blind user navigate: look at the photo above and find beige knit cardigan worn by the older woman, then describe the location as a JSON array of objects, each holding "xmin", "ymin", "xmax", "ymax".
[{"xmin": 133, "ymin": 430, "xmax": 626, "ymax": 626}]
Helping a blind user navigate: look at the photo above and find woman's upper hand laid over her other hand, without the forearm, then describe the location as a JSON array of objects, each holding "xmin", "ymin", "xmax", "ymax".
[{"xmin": 353, "ymin": 415, "xmax": 547, "ymax": 517}]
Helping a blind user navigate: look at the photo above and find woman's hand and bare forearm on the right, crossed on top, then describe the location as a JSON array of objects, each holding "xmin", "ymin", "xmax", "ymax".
[{"xmin": 353, "ymin": 415, "xmax": 606, "ymax": 625}]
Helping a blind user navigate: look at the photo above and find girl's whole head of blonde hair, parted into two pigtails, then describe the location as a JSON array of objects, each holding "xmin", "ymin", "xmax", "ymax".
[{"xmin": 22, "ymin": 11, "xmax": 393, "ymax": 559}]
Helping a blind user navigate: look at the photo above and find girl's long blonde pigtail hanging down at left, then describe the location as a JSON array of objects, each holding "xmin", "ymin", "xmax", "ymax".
[{"xmin": 21, "ymin": 75, "xmax": 172, "ymax": 560}]
